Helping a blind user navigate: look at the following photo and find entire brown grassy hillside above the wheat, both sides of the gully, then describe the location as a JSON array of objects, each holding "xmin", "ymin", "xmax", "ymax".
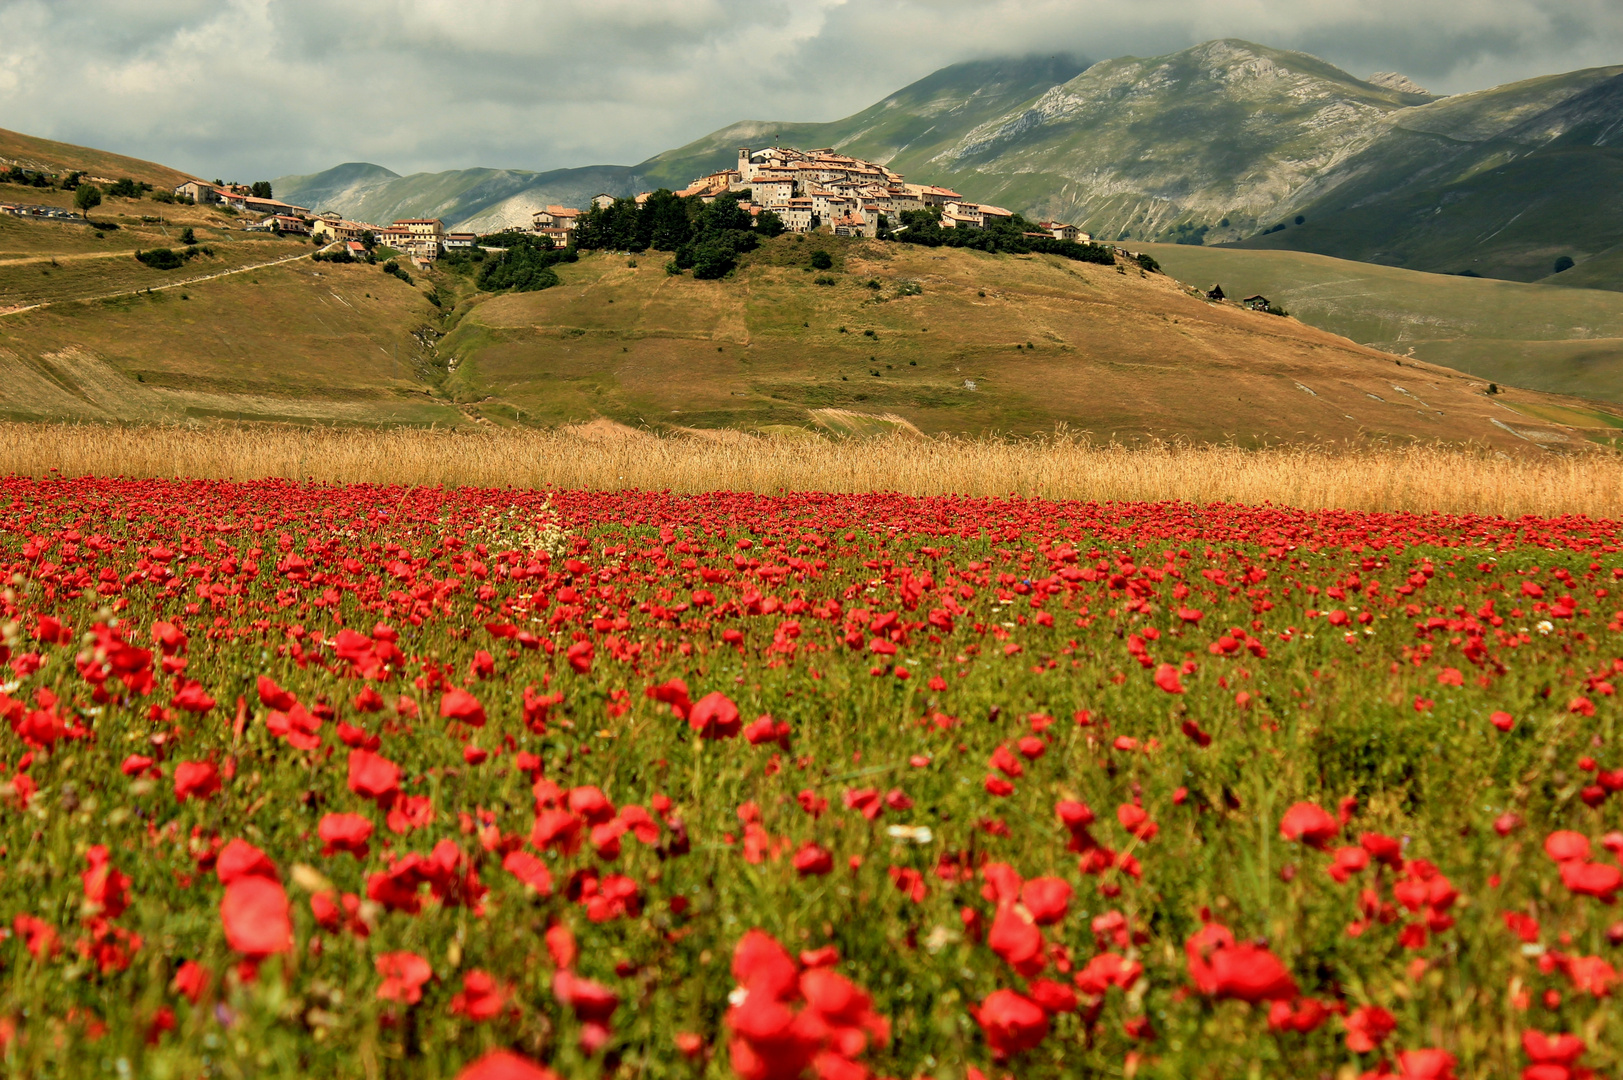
[{"xmin": 0, "ymin": 174, "xmax": 1616, "ymax": 445}]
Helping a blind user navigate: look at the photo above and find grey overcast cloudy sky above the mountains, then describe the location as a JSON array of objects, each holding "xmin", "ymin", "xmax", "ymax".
[{"xmin": 0, "ymin": 0, "xmax": 1623, "ymax": 180}]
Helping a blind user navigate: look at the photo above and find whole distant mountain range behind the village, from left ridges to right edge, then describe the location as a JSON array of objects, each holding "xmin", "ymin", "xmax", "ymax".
[{"xmin": 276, "ymin": 39, "xmax": 1623, "ymax": 289}]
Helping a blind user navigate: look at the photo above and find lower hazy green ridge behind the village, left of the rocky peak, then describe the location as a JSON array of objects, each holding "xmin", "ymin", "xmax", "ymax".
[{"xmin": 273, "ymin": 55, "xmax": 1086, "ymax": 232}]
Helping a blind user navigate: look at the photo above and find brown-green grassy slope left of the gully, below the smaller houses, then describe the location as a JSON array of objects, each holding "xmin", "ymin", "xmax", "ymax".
[{"xmin": 0, "ymin": 187, "xmax": 464, "ymax": 424}]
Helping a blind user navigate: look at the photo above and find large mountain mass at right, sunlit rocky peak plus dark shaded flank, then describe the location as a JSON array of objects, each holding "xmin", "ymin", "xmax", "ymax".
[{"xmin": 920, "ymin": 41, "xmax": 1623, "ymax": 289}]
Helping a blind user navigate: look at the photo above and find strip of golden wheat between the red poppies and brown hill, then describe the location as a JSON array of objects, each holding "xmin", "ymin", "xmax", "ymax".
[{"xmin": 0, "ymin": 421, "xmax": 1623, "ymax": 518}]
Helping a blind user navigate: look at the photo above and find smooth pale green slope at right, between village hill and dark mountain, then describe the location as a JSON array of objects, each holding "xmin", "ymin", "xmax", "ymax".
[{"xmin": 1149, "ymin": 245, "xmax": 1623, "ymax": 403}]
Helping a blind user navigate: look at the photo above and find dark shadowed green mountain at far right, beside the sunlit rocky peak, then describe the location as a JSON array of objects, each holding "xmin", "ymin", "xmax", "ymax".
[{"xmin": 1242, "ymin": 67, "xmax": 1623, "ymax": 282}]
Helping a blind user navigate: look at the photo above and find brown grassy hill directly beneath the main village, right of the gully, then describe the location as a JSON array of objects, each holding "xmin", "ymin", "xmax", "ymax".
[{"xmin": 443, "ymin": 237, "xmax": 1610, "ymax": 445}]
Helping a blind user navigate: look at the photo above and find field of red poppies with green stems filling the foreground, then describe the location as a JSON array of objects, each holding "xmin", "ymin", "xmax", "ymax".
[{"xmin": 0, "ymin": 477, "xmax": 1623, "ymax": 1080}]
